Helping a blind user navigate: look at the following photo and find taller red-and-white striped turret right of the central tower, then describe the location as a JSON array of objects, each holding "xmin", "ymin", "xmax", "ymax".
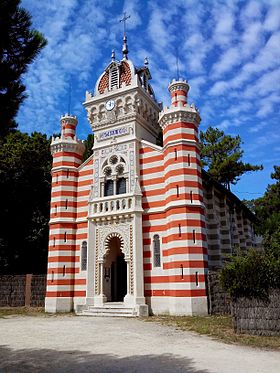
[{"xmin": 159, "ymin": 80, "xmax": 208, "ymax": 314}]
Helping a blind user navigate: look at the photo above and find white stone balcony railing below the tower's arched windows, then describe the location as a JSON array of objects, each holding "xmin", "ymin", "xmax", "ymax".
[{"xmin": 89, "ymin": 194, "xmax": 142, "ymax": 218}]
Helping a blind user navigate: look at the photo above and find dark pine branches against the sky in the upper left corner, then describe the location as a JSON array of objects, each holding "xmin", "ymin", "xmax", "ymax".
[{"xmin": 0, "ymin": 0, "xmax": 47, "ymax": 136}]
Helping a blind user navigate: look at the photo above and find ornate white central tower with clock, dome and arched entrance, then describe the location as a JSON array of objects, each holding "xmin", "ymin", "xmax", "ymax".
[{"xmin": 84, "ymin": 35, "xmax": 161, "ymax": 315}]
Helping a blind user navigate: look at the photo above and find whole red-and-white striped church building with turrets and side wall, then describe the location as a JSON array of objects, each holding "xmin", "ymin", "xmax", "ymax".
[{"xmin": 46, "ymin": 59, "xmax": 253, "ymax": 315}]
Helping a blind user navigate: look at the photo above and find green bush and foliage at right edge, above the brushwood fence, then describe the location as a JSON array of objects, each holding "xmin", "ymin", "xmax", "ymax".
[{"xmin": 221, "ymin": 166, "xmax": 280, "ymax": 298}]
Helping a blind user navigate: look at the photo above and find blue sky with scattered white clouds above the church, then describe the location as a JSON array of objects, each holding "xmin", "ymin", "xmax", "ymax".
[{"xmin": 17, "ymin": 0, "xmax": 280, "ymax": 199}]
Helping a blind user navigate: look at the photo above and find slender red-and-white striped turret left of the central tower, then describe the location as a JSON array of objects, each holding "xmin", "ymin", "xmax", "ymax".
[{"xmin": 46, "ymin": 114, "xmax": 84, "ymax": 312}]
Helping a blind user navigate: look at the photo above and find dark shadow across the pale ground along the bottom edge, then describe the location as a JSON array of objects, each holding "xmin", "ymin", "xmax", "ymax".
[{"xmin": 0, "ymin": 346, "xmax": 209, "ymax": 373}]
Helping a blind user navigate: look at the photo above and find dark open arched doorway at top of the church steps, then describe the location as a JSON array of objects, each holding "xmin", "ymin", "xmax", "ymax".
[{"xmin": 103, "ymin": 236, "xmax": 127, "ymax": 302}]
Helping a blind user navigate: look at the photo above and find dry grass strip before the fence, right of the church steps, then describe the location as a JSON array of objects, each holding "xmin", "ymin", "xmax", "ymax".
[{"xmin": 147, "ymin": 316, "xmax": 280, "ymax": 350}]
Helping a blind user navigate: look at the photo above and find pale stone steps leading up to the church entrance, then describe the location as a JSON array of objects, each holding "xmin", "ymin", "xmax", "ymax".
[{"xmin": 76, "ymin": 302, "xmax": 137, "ymax": 317}]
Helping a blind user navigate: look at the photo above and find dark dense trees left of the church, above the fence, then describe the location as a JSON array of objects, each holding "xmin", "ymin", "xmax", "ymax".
[{"xmin": 0, "ymin": 131, "xmax": 52, "ymax": 274}]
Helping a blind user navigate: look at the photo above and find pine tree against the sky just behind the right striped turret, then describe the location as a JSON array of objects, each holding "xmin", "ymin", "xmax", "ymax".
[{"xmin": 199, "ymin": 127, "xmax": 263, "ymax": 189}]
